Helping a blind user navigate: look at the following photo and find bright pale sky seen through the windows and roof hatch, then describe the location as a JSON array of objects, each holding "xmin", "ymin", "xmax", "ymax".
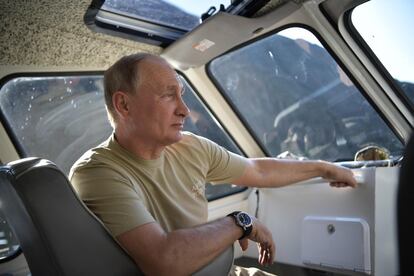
[{"xmin": 167, "ymin": 0, "xmax": 414, "ymax": 83}]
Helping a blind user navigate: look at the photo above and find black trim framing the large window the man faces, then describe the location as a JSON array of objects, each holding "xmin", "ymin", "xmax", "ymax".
[{"xmin": 205, "ymin": 23, "xmax": 404, "ymax": 156}]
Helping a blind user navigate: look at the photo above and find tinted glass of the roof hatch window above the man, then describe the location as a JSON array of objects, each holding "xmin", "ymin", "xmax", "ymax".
[{"xmin": 102, "ymin": 0, "xmax": 230, "ymax": 31}]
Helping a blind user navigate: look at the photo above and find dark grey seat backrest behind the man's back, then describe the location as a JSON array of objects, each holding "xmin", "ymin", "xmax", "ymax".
[{"xmin": 0, "ymin": 158, "xmax": 142, "ymax": 276}]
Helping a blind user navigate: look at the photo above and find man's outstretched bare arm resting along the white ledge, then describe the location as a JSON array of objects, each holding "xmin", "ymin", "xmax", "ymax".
[{"xmin": 232, "ymin": 158, "xmax": 357, "ymax": 188}]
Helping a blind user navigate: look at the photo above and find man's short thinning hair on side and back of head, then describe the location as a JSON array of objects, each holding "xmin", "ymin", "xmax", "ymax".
[{"xmin": 104, "ymin": 53, "xmax": 159, "ymax": 127}]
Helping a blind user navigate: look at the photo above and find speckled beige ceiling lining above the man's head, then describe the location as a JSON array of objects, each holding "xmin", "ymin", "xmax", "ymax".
[{"xmin": 0, "ymin": 0, "xmax": 162, "ymax": 72}]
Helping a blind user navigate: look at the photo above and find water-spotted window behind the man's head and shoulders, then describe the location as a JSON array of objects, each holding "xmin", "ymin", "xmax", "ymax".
[{"xmin": 0, "ymin": 75, "xmax": 242, "ymax": 200}]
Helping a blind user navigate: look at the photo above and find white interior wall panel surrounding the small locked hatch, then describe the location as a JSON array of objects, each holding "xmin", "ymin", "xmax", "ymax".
[{"xmin": 245, "ymin": 167, "xmax": 398, "ymax": 275}]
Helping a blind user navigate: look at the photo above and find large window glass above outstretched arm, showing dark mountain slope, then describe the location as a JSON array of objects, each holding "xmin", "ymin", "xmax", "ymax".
[{"xmin": 209, "ymin": 28, "xmax": 403, "ymax": 161}]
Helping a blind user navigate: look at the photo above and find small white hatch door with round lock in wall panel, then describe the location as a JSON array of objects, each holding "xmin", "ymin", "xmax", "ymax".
[{"xmin": 301, "ymin": 216, "xmax": 371, "ymax": 274}]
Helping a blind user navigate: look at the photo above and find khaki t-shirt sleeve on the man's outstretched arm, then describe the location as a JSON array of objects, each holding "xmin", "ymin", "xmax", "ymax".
[{"xmin": 192, "ymin": 136, "xmax": 248, "ymax": 184}]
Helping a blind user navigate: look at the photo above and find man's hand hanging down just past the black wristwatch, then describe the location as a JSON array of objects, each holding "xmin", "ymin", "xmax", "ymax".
[{"xmin": 239, "ymin": 217, "xmax": 276, "ymax": 265}]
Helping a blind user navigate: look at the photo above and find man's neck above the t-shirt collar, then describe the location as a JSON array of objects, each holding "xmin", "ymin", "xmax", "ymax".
[{"xmin": 115, "ymin": 131, "xmax": 165, "ymax": 160}]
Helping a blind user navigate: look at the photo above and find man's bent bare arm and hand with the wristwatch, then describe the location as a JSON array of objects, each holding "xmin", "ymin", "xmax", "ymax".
[{"xmin": 117, "ymin": 217, "xmax": 275, "ymax": 275}]
